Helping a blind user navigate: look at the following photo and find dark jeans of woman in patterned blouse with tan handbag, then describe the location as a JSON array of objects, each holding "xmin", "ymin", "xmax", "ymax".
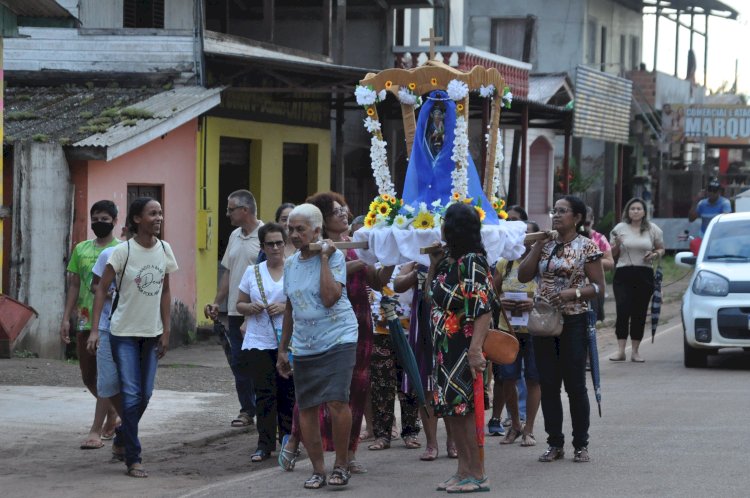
[{"xmin": 534, "ymin": 313, "xmax": 590, "ymax": 448}]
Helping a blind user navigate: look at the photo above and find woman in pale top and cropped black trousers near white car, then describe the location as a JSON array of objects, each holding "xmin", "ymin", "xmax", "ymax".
[{"xmin": 609, "ymin": 197, "xmax": 664, "ymax": 363}]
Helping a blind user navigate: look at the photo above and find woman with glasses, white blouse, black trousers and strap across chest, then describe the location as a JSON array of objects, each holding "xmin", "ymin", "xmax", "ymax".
[{"xmin": 237, "ymin": 223, "xmax": 294, "ymax": 462}]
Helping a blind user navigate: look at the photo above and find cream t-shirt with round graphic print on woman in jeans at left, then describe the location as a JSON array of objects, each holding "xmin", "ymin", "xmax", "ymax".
[{"xmin": 107, "ymin": 239, "xmax": 177, "ymax": 337}]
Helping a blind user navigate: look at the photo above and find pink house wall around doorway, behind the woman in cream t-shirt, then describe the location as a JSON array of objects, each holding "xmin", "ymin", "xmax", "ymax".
[{"xmin": 87, "ymin": 119, "xmax": 198, "ymax": 313}]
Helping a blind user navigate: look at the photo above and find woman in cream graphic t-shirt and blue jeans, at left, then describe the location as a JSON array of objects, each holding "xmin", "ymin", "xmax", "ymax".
[{"xmin": 87, "ymin": 197, "xmax": 177, "ymax": 477}]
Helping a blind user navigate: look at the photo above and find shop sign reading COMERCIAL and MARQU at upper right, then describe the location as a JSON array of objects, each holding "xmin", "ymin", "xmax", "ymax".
[{"xmin": 662, "ymin": 104, "xmax": 750, "ymax": 145}]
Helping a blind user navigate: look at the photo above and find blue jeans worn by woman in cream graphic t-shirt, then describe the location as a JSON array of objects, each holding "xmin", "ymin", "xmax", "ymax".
[{"xmin": 110, "ymin": 335, "xmax": 161, "ymax": 467}]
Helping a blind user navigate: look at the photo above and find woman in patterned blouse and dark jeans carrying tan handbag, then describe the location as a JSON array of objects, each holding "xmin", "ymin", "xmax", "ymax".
[{"xmin": 518, "ymin": 195, "xmax": 605, "ymax": 462}]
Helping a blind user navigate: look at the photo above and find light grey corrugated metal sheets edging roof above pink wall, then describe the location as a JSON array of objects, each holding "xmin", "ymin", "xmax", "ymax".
[{"xmin": 73, "ymin": 86, "xmax": 223, "ymax": 161}]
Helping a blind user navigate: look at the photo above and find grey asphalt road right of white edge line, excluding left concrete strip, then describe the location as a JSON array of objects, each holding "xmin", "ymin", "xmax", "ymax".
[{"xmin": 184, "ymin": 321, "xmax": 750, "ymax": 497}]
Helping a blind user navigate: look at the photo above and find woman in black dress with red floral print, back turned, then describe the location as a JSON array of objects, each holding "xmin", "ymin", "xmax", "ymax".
[{"xmin": 427, "ymin": 204, "xmax": 497, "ymax": 493}]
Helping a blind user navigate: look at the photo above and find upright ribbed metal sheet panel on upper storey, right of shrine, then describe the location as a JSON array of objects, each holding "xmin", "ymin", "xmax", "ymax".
[{"xmin": 573, "ymin": 66, "xmax": 633, "ymax": 143}]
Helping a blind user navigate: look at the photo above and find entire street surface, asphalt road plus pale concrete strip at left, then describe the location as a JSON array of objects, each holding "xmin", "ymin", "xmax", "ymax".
[{"xmin": 0, "ymin": 312, "xmax": 750, "ymax": 498}]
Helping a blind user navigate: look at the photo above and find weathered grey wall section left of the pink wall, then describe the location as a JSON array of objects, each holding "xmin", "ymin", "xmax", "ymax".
[{"xmin": 10, "ymin": 142, "xmax": 72, "ymax": 358}]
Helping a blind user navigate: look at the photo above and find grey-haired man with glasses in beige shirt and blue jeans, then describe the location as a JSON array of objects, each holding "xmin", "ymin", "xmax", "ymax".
[{"xmin": 204, "ymin": 190, "xmax": 263, "ymax": 427}]
